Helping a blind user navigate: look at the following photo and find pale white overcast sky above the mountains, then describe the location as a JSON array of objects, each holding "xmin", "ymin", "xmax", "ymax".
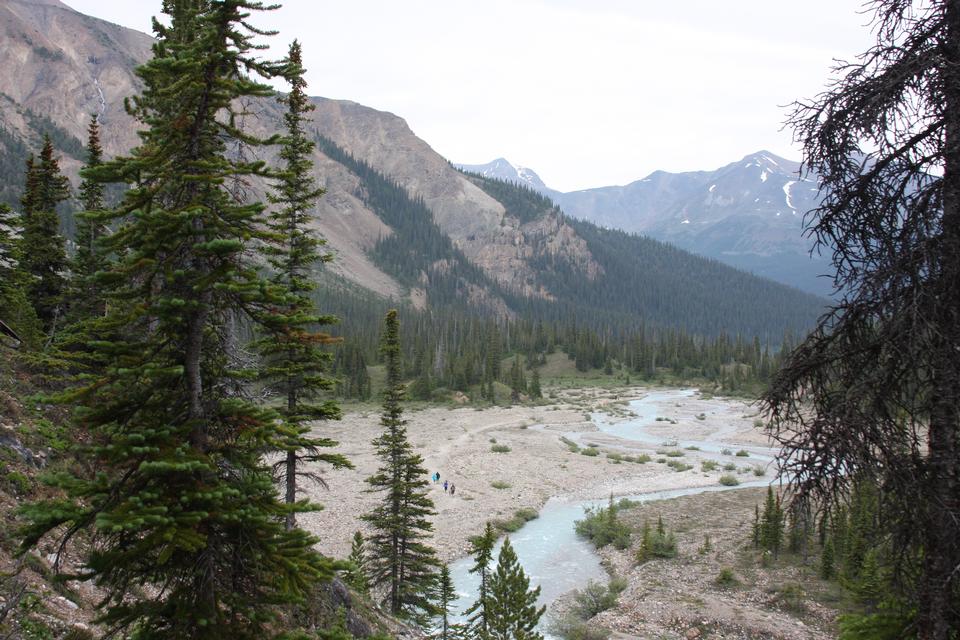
[{"xmin": 66, "ymin": 0, "xmax": 872, "ymax": 191}]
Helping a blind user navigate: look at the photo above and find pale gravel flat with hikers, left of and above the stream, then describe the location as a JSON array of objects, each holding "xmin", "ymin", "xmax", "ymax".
[{"xmin": 300, "ymin": 387, "xmax": 772, "ymax": 561}]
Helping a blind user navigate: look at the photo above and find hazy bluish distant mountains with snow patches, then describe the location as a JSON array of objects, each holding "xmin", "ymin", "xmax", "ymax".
[{"xmin": 458, "ymin": 151, "xmax": 832, "ymax": 295}]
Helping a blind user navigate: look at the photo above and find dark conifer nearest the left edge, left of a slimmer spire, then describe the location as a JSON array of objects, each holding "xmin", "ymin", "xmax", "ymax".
[{"xmin": 20, "ymin": 135, "xmax": 70, "ymax": 333}]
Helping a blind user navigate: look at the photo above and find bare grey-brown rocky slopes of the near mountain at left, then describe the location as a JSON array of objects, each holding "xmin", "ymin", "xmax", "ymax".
[{"xmin": 0, "ymin": 0, "xmax": 598, "ymax": 308}]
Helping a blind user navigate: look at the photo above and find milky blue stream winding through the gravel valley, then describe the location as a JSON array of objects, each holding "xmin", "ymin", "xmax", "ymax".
[{"xmin": 450, "ymin": 389, "xmax": 775, "ymax": 640}]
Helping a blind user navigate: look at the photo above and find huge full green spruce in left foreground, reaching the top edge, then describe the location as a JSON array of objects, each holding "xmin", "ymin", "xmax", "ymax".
[{"xmin": 23, "ymin": 0, "xmax": 334, "ymax": 639}]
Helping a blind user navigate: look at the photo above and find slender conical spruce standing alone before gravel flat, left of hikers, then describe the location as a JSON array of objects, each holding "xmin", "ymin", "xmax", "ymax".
[{"xmin": 363, "ymin": 309, "xmax": 439, "ymax": 625}]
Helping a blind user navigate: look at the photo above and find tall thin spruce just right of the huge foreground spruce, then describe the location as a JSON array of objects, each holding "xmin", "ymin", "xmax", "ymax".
[{"xmin": 257, "ymin": 40, "xmax": 352, "ymax": 529}]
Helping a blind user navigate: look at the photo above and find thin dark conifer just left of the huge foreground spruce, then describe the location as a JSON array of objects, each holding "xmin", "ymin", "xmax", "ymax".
[{"xmin": 70, "ymin": 115, "xmax": 107, "ymax": 321}]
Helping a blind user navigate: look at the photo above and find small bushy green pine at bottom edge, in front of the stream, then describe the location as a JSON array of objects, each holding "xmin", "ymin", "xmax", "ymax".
[{"xmin": 487, "ymin": 538, "xmax": 546, "ymax": 640}]
